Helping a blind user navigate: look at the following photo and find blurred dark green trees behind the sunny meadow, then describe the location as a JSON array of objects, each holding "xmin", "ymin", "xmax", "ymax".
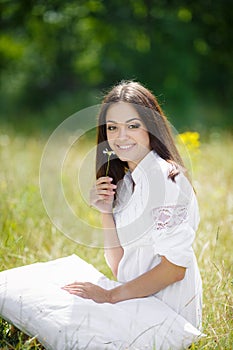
[{"xmin": 0, "ymin": 0, "xmax": 233, "ymax": 133}]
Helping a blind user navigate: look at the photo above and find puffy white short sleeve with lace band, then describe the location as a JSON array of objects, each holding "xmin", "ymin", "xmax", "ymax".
[{"xmin": 151, "ymin": 173, "xmax": 199, "ymax": 268}]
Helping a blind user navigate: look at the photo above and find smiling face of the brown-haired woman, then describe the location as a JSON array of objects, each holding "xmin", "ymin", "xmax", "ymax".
[{"xmin": 106, "ymin": 102, "xmax": 151, "ymax": 171}]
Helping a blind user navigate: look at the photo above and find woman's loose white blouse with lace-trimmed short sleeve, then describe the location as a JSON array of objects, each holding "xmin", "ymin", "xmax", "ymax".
[{"xmin": 114, "ymin": 151, "xmax": 202, "ymax": 328}]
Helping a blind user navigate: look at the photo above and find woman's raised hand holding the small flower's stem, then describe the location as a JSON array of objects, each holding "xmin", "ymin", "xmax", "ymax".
[{"xmin": 90, "ymin": 176, "xmax": 117, "ymax": 213}]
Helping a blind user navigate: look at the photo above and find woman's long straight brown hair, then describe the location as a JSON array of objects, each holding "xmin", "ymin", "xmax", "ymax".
[{"xmin": 96, "ymin": 81, "xmax": 187, "ymax": 183}]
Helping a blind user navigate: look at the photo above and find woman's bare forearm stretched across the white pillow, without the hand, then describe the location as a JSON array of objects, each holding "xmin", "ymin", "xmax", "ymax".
[{"xmin": 109, "ymin": 257, "xmax": 185, "ymax": 303}]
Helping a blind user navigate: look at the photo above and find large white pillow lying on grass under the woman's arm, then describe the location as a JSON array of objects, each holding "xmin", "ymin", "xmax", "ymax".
[{"xmin": 0, "ymin": 255, "xmax": 203, "ymax": 350}]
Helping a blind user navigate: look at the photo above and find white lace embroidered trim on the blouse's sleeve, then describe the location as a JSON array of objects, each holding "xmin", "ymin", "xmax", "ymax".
[{"xmin": 152, "ymin": 205, "xmax": 188, "ymax": 230}]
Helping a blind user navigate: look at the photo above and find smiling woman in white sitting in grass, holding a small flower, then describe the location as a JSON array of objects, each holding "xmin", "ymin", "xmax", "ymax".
[{"xmin": 64, "ymin": 82, "xmax": 202, "ymax": 344}]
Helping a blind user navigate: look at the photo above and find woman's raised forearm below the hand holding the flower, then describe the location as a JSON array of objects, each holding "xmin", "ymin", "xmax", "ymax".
[{"xmin": 102, "ymin": 213, "xmax": 124, "ymax": 277}]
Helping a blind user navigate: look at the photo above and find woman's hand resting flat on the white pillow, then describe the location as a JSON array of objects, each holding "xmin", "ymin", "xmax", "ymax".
[{"xmin": 62, "ymin": 282, "xmax": 110, "ymax": 303}]
